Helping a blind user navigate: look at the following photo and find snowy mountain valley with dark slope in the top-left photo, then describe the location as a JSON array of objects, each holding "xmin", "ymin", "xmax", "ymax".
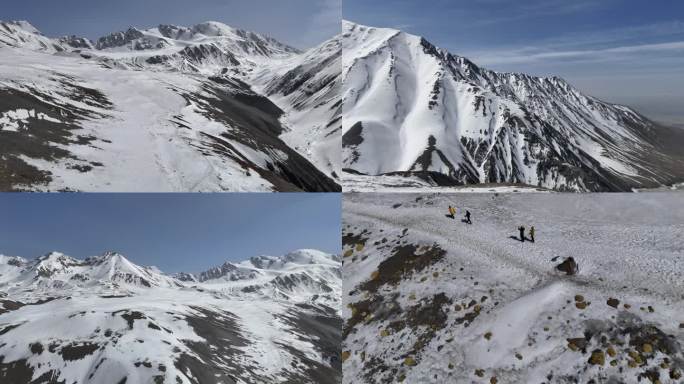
[{"xmin": 0, "ymin": 21, "xmax": 341, "ymax": 191}]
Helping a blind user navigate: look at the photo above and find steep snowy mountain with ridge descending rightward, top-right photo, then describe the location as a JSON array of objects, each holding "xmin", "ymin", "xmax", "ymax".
[{"xmin": 342, "ymin": 21, "xmax": 684, "ymax": 191}]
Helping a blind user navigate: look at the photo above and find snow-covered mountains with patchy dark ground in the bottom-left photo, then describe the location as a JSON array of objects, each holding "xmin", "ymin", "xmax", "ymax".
[{"xmin": 0, "ymin": 250, "xmax": 342, "ymax": 384}]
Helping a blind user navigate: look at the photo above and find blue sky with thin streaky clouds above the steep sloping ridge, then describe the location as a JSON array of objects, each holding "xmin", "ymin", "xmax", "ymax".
[{"xmin": 343, "ymin": 0, "xmax": 684, "ymax": 126}]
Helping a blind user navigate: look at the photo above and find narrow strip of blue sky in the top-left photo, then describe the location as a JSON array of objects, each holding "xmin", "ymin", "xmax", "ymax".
[{"xmin": 0, "ymin": 0, "xmax": 342, "ymax": 48}]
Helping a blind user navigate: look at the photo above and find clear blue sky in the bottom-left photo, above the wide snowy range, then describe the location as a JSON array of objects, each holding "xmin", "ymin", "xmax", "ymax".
[{"xmin": 0, "ymin": 193, "xmax": 341, "ymax": 273}]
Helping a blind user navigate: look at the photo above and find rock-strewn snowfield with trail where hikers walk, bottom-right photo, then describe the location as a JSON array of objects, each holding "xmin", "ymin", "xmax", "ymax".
[{"xmin": 342, "ymin": 192, "xmax": 684, "ymax": 383}]
